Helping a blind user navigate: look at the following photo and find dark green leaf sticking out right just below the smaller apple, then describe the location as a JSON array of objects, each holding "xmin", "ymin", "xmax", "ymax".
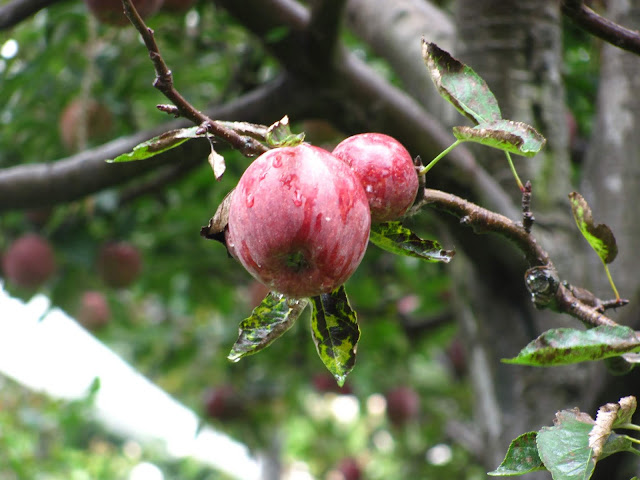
[{"xmin": 369, "ymin": 222, "xmax": 456, "ymax": 263}]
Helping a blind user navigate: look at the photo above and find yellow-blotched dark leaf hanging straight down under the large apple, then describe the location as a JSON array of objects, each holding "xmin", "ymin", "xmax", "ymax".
[{"xmin": 311, "ymin": 286, "xmax": 360, "ymax": 386}]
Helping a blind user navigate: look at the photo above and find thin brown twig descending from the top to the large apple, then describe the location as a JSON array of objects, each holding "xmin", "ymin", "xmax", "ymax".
[{"xmin": 122, "ymin": 0, "xmax": 268, "ymax": 157}]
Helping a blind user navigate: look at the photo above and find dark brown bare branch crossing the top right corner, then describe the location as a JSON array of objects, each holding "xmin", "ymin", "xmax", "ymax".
[{"xmin": 562, "ymin": 0, "xmax": 640, "ymax": 55}]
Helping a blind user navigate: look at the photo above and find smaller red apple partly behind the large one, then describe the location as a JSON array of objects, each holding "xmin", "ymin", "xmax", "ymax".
[{"xmin": 333, "ymin": 133, "xmax": 418, "ymax": 223}]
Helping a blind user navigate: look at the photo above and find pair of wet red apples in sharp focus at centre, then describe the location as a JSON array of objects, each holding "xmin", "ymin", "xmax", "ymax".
[{"xmin": 226, "ymin": 129, "xmax": 418, "ymax": 298}]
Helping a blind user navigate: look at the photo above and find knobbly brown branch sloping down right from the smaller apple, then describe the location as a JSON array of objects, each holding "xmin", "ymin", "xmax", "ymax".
[{"xmin": 420, "ymin": 189, "xmax": 616, "ymax": 327}]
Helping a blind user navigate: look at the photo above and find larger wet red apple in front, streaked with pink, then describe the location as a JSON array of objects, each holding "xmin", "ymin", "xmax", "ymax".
[{"xmin": 227, "ymin": 144, "xmax": 371, "ymax": 298}]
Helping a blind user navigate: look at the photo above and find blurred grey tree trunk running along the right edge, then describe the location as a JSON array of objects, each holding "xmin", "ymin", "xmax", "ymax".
[{"xmin": 581, "ymin": 0, "xmax": 640, "ymax": 479}]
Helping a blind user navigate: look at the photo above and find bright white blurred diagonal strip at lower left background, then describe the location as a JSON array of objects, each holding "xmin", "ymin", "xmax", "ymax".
[{"xmin": 0, "ymin": 283, "xmax": 260, "ymax": 480}]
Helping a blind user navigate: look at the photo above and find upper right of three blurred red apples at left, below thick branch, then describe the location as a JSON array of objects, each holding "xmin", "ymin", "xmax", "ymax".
[{"xmin": 98, "ymin": 242, "xmax": 142, "ymax": 288}]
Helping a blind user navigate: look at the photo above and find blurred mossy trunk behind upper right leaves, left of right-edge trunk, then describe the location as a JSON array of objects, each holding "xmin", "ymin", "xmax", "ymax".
[{"xmin": 456, "ymin": 0, "xmax": 593, "ymax": 472}]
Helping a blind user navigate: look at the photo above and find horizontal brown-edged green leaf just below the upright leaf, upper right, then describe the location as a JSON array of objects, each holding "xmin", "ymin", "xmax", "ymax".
[{"xmin": 453, "ymin": 120, "xmax": 547, "ymax": 157}]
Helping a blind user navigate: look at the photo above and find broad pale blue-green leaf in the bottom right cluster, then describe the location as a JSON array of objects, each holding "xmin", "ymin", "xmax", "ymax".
[{"xmin": 537, "ymin": 409, "xmax": 596, "ymax": 480}]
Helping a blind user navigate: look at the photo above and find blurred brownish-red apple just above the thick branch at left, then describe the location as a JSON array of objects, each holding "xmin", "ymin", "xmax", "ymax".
[{"xmin": 58, "ymin": 98, "xmax": 113, "ymax": 151}]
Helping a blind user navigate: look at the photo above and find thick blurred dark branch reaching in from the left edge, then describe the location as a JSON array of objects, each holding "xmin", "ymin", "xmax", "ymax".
[{"xmin": 0, "ymin": 77, "xmax": 313, "ymax": 212}]
